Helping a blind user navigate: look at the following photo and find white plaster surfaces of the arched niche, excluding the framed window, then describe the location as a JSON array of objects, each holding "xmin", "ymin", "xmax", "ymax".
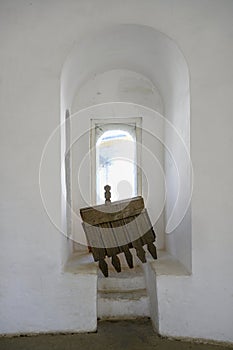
[{"xmin": 61, "ymin": 25, "xmax": 192, "ymax": 271}]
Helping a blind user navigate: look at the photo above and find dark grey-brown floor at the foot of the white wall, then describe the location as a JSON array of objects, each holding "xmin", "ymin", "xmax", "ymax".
[{"xmin": 0, "ymin": 319, "xmax": 233, "ymax": 350}]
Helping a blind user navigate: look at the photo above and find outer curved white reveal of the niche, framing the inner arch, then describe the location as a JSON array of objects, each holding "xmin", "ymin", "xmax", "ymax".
[{"xmin": 61, "ymin": 24, "xmax": 191, "ymax": 270}]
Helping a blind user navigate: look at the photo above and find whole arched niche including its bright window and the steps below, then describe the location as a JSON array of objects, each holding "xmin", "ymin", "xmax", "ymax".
[{"xmin": 61, "ymin": 25, "xmax": 191, "ymax": 323}]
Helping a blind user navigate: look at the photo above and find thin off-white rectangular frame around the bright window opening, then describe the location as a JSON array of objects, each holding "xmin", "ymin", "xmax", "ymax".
[{"xmin": 90, "ymin": 117, "xmax": 142, "ymax": 205}]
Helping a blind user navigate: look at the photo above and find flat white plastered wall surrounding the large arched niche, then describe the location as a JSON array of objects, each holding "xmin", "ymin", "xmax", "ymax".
[{"xmin": 0, "ymin": 0, "xmax": 233, "ymax": 342}]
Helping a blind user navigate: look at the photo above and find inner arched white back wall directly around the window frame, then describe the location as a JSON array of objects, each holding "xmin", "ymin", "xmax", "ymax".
[{"xmin": 71, "ymin": 69, "xmax": 165, "ymax": 249}]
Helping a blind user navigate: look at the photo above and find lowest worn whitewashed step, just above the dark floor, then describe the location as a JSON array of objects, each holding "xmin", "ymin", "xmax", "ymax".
[{"xmin": 97, "ymin": 289, "xmax": 150, "ymax": 319}]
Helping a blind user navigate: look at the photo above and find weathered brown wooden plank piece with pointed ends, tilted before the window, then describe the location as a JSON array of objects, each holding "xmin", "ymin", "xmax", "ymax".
[{"xmin": 80, "ymin": 185, "xmax": 157, "ymax": 277}]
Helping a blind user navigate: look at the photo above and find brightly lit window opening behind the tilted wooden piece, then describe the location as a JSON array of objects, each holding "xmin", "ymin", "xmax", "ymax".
[{"xmin": 96, "ymin": 124, "xmax": 137, "ymax": 204}]
